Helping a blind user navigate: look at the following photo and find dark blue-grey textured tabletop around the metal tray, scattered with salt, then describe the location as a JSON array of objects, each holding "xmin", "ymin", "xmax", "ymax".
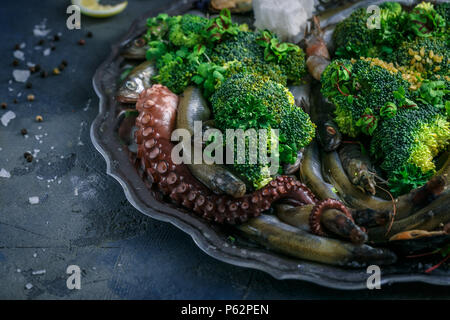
[{"xmin": 0, "ymin": 0, "xmax": 450, "ymax": 299}]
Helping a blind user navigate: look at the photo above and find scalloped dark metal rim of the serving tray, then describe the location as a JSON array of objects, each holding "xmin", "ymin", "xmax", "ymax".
[{"xmin": 91, "ymin": 1, "xmax": 450, "ymax": 289}]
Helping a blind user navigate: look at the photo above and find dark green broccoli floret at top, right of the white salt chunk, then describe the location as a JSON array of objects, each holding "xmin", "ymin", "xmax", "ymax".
[{"xmin": 333, "ymin": 2, "xmax": 408, "ymax": 58}]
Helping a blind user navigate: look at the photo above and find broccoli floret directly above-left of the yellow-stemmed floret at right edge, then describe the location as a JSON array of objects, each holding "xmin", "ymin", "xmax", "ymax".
[{"xmin": 321, "ymin": 58, "xmax": 411, "ymax": 137}]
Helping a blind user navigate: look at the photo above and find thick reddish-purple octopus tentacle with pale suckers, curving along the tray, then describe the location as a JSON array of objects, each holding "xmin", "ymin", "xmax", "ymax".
[{"xmin": 135, "ymin": 84, "xmax": 317, "ymax": 224}]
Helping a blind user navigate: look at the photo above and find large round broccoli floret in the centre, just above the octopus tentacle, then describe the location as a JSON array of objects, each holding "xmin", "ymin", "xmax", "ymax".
[{"xmin": 211, "ymin": 73, "xmax": 315, "ymax": 188}]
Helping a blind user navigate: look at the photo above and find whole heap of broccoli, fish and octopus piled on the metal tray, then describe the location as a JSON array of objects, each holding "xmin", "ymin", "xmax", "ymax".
[{"xmin": 116, "ymin": 3, "xmax": 450, "ymax": 271}]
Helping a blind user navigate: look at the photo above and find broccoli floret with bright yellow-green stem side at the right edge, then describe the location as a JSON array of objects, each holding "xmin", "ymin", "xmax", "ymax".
[{"xmin": 370, "ymin": 102, "xmax": 450, "ymax": 176}]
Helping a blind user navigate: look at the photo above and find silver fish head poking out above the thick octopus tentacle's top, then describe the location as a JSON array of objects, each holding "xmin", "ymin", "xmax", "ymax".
[{"xmin": 116, "ymin": 61, "xmax": 156, "ymax": 103}]
